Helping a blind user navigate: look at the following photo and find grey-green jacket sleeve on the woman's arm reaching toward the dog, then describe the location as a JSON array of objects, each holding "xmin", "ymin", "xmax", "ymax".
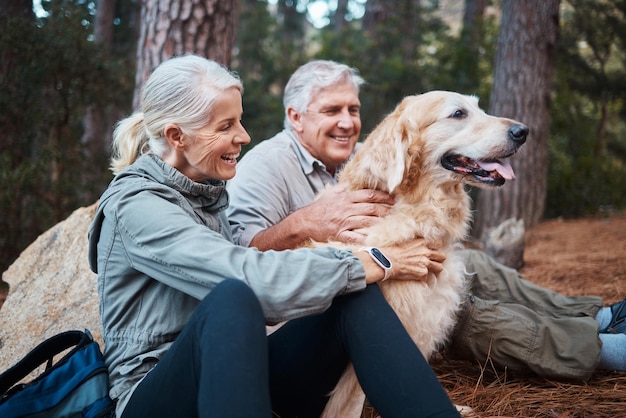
[{"xmin": 90, "ymin": 182, "xmax": 365, "ymax": 322}]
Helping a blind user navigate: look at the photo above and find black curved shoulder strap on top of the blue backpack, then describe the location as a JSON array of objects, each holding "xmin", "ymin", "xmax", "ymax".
[{"xmin": 0, "ymin": 330, "xmax": 93, "ymax": 398}]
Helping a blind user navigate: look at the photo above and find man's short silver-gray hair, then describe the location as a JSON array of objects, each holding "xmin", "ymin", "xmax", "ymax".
[{"xmin": 283, "ymin": 60, "xmax": 365, "ymax": 131}]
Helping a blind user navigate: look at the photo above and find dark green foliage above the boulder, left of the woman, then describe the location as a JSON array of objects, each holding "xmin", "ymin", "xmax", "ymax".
[{"xmin": 0, "ymin": 1, "xmax": 130, "ymax": 271}]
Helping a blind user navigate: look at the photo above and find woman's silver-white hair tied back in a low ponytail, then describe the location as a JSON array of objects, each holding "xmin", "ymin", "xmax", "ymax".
[{"xmin": 111, "ymin": 55, "xmax": 243, "ymax": 173}]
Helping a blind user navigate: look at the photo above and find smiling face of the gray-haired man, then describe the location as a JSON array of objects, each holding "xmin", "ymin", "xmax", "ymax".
[{"xmin": 292, "ymin": 82, "xmax": 361, "ymax": 174}]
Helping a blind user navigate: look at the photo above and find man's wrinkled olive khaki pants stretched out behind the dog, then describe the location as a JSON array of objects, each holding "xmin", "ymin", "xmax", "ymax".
[{"xmin": 446, "ymin": 250, "xmax": 602, "ymax": 381}]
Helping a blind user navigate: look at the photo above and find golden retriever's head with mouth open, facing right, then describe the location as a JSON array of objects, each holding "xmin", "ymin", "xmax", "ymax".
[{"xmin": 346, "ymin": 91, "xmax": 528, "ymax": 193}]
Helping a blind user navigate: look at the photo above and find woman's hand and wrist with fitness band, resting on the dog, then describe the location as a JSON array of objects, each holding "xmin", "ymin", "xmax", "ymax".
[{"xmin": 355, "ymin": 238, "xmax": 446, "ymax": 284}]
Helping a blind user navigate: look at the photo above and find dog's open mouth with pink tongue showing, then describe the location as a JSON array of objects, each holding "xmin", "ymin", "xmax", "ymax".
[{"xmin": 441, "ymin": 154, "xmax": 515, "ymax": 186}]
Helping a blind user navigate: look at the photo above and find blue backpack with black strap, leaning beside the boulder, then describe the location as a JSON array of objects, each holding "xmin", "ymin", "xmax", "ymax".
[{"xmin": 0, "ymin": 330, "xmax": 115, "ymax": 418}]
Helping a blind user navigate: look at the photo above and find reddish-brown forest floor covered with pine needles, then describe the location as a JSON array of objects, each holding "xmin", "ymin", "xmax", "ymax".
[{"xmin": 363, "ymin": 214, "xmax": 626, "ymax": 418}]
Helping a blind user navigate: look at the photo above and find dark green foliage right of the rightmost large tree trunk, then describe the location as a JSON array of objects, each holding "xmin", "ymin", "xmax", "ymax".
[{"xmin": 545, "ymin": 0, "xmax": 626, "ymax": 218}]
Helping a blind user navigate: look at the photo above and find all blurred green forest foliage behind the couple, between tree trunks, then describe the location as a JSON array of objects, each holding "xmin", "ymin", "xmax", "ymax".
[{"xmin": 0, "ymin": 0, "xmax": 626, "ymax": 271}]
